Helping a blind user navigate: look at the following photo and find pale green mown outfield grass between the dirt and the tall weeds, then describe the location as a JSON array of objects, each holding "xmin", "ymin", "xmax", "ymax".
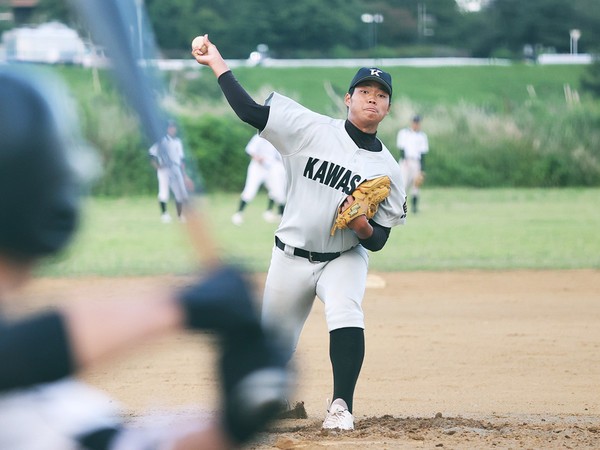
[{"xmin": 40, "ymin": 188, "xmax": 600, "ymax": 277}]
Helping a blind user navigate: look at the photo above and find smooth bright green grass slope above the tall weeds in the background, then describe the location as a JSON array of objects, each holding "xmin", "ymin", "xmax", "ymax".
[{"xmin": 56, "ymin": 63, "xmax": 586, "ymax": 113}]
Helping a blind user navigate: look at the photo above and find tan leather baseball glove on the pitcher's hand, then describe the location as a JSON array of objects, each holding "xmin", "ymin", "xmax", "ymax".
[{"xmin": 331, "ymin": 176, "xmax": 391, "ymax": 236}]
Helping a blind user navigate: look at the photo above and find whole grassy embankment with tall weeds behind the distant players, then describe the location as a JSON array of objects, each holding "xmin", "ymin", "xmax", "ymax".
[{"xmin": 51, "ymin": 65, "xmax": 600, "ymax": 192}]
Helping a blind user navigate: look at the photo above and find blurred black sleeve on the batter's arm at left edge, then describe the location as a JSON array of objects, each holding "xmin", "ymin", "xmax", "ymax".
[{"xmin": 0, "ymin": 311, "xmax": 74, "ymax": 391}]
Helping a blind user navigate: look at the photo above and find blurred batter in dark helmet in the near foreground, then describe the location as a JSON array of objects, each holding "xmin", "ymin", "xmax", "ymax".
[{"xmin": 0, "ymin": 67, "xmax": 287, "ymax": 450}]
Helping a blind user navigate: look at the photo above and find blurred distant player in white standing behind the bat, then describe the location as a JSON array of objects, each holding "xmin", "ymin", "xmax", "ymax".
[{"xmin": 148, "ymin": 120, "xmax": 188, "ymax": 223}]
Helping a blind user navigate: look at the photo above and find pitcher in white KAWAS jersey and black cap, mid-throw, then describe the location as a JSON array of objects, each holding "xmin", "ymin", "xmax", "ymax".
[{"xmin": 192, "ymin": 35, "xmax": 406, "ymax": 430}]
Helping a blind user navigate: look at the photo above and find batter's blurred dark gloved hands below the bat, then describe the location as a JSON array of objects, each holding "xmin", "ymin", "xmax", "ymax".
[{"xmin": 180, "ymin": 267, "xmax": 290, "ymax": 444}]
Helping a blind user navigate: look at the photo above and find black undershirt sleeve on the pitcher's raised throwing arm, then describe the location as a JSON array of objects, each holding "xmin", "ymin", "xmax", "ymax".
[{"xmin": 218, "ymin": 70, "xmax": 270, "ymax": 130}]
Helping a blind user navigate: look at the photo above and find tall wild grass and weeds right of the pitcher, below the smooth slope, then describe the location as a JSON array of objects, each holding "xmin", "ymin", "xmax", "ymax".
[{"xmin": 380, "ymin": 98, "xmax": 600, "ymax": 187}]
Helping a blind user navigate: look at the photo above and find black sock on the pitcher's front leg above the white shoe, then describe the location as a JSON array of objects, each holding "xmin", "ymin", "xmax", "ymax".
[{"xmin": 329, "ymin": 328, "xmax": 365, "ymax": 412}]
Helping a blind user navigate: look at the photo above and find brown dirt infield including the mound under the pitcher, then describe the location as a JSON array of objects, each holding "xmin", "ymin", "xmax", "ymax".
[{"xmin": 12, "ymin": 270, "xmax": 600, "ymax": 449}]
